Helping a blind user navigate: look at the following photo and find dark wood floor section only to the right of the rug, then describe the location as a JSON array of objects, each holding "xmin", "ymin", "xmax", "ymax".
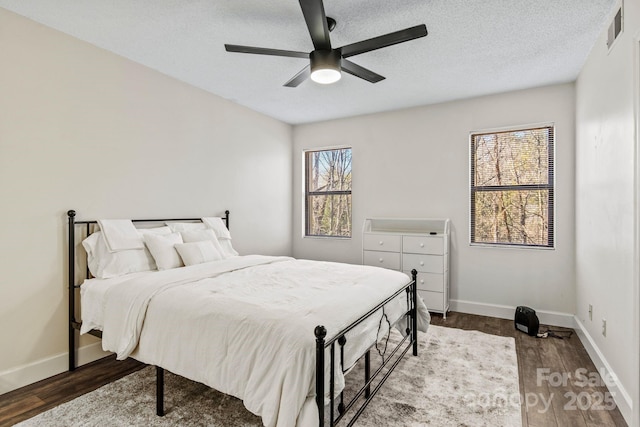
[{"xmin": 431, "ymin": 313, "xmax": 627, "ymax": 427}]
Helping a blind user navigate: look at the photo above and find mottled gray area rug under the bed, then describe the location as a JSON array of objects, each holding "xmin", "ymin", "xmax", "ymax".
[{"xmin": 18, "ymin": 325, "xmax": 522, "ymax": 427}]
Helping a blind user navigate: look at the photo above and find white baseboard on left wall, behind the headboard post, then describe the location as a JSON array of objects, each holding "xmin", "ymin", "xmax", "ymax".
[{"xmin": 0, "ymin": 342, "xmax": 111, "ymax": 394}]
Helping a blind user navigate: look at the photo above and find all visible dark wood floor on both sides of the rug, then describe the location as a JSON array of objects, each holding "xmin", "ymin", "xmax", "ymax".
[{"xmin": 0, "ymin": 313, "xmax": 627, "ymax": 427}]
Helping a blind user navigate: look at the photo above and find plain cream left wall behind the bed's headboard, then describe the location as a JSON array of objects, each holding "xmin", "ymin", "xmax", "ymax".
[{"xmin": 0, "ymin": 9, "xmax": 292, "ymax": 393}]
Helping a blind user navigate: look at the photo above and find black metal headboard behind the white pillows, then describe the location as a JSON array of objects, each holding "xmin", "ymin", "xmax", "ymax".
[{"xmin": 67, "ymin": 210, "xmax": 229, "ymax": 371}]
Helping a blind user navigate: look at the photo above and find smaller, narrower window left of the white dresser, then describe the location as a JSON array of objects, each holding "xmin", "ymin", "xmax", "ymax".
[{"xmin": 305, "ymin": 148, "xmax": 351, "ymax": 237}]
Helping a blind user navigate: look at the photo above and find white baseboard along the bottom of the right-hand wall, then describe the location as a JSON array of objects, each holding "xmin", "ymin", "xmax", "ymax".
[{"xmin": 574, "ymin": 317, "xmax": 634, "ymax": 425}]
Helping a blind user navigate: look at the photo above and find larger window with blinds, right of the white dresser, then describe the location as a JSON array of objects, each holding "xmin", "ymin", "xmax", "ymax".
[{"xmin": 470, "ymin": 126, "xmax": 554, "ymax": 248}]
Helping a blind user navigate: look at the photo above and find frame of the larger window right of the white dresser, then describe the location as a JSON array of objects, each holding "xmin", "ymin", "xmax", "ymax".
[{"xmin": 468, "ymin": 123, "xmax": 556, "ymax": 250}]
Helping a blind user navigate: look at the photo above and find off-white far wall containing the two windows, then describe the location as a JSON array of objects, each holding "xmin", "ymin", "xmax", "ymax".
[{"xmin": 293, "ymin": 84, "xmax": 575, "ymax": 320}]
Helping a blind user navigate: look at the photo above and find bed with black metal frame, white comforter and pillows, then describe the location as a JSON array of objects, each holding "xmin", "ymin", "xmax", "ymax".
[{"xmin": 68, "ymin": 211, "xmax": 429, "ymax": 427}]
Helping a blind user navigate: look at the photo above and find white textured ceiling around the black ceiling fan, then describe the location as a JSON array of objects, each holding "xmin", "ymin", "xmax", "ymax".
[{"xmin": 0, "ymin": 0, "xmax": 615, "ymax": 124}]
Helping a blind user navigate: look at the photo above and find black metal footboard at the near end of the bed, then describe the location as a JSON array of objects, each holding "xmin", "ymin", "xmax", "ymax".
[{"xmin": 314, "ymin": 270, "xmax": 418, "ymax": 427}]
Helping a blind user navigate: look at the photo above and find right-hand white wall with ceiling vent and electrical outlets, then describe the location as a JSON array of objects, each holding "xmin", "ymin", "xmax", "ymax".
[{"xmin": 576, "ymin": 1, "xmax": 640, "ymax": 425}]
